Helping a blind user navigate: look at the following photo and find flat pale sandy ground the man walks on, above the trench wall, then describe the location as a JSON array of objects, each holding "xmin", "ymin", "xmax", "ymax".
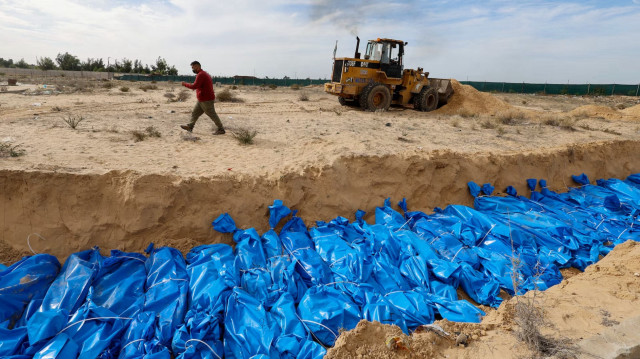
[{"xmin": 0, "ymin": 81, "xmax": 640, "ymax": 177}]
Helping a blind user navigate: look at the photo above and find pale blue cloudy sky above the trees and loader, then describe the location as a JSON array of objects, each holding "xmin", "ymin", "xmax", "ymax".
[{"xmin": 0, "ymin": 0, "xmax": 640, "ymax": 84}]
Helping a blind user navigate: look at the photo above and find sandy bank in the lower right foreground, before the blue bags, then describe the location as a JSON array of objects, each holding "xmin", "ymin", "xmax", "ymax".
[{"xmin": 327, "ymin": 241, "xmax": 640, "ymax": 359}]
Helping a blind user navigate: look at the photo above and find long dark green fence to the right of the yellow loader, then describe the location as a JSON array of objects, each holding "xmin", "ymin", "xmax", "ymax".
[{"xmin": 460, "ymin": 81, "xmax": 640, "ymax": 96}]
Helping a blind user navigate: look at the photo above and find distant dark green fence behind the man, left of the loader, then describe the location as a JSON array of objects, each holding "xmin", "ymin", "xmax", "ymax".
[{"xmin": 116, "ymin": 74, "xmax": 330, "ymax": 86}]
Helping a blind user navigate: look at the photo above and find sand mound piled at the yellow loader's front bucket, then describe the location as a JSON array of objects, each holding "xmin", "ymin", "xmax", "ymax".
[{"xmin": 433, "ymin": 79, "xmax": 513, "ymax": 115}]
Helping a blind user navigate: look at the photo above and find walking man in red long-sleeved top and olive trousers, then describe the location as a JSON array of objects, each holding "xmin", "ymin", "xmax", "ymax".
[{"xmin": 180, "ymin": 61, "xmax": 225, "ymax": 135}]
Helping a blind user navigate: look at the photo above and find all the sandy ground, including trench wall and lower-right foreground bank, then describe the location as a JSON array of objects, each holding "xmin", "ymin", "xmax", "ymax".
[{"xmin": 0, "ymin": 79, "xmax": 640, "ymax": 358}]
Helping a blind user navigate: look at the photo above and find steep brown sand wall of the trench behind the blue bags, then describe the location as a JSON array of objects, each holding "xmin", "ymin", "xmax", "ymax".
[{"xmin": 0, "ymin": 141, "xmax": 640, "ymax": 265}]
